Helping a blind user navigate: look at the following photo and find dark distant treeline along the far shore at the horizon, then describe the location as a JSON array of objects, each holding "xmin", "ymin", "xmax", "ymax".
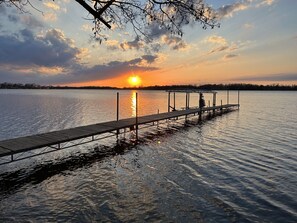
[{"xmin": 0, "ymin": 82, "xmax": 297, "ymax": 91}]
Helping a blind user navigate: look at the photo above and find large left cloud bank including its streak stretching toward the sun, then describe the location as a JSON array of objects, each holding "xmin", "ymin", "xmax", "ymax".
[{"xmin": 0, "ymin": 29, "xmax": 159, "ymax": 85}]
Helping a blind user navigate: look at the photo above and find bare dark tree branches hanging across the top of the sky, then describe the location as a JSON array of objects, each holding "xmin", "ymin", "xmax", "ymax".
[{"xmin": 0, "ymin": 0, "xmax": 219, "ymax": 41}]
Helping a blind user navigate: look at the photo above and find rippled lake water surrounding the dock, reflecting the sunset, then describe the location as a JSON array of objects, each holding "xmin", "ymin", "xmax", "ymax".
[{"xmin": 0, "ymin": 90, "xmax": 297, "ymax": 222}]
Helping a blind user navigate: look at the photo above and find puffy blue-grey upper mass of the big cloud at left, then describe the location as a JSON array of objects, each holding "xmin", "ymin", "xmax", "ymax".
[{"xmin": 0, "ymin": 29, "xmax": 80, "ymax": 67}]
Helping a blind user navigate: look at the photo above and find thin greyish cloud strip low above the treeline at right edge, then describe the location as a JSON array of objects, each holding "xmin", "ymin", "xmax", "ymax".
[{"xmin": 233, "ymin": 73, "xmax": 297, "ymax": 82}]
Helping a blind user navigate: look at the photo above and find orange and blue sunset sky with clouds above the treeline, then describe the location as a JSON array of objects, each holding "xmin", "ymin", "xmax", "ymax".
[{"xmin": 0, "ymin": 0, "xmax": 297, "ymax": 87}]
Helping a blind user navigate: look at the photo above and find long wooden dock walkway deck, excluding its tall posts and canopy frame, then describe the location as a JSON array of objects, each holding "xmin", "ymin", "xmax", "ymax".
[{"xmin": 0, "ymin": 104, "xmax": 239, "ymax": 164}]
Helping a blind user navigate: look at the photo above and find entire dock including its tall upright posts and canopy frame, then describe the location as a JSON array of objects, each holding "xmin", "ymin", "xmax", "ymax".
[{"xmin": 0, "ymin": 91, "xmax": 239, "ymax": 165}]
